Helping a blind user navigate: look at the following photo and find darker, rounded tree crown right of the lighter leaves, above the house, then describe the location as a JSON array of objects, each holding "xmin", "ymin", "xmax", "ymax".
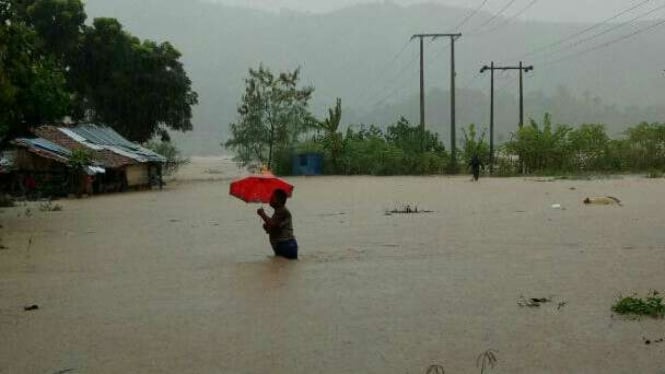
[{"xmin": 71, "ymin": 18, "xmax": 198, "ymax": 142}]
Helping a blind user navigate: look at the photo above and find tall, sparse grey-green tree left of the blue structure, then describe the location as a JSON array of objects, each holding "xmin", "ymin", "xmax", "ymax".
[{"xmin": 225, "ymin": 65, "xmax": 316, "ymax": 168}]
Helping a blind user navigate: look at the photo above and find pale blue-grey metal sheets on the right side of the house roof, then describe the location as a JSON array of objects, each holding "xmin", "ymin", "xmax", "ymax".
[{"xmin": 68, "ymin": 125, "xmax": 166, "ymax": 162}]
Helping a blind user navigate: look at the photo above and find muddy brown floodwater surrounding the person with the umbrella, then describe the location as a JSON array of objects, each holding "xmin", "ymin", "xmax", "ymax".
[{"xmin": 0, "ymin": 159, "xmax": 665, "ymax": 373}]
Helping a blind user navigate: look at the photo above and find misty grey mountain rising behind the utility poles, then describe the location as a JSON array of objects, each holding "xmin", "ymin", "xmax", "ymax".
[{"xmin": 86, "ymin": 0, "xmax": 665, "ymax": 154}]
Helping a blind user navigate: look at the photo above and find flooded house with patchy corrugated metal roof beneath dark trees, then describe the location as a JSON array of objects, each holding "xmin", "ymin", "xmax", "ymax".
[{"xmin": 3, "ymin": 124, "xmax": 166, "ymax": 199}]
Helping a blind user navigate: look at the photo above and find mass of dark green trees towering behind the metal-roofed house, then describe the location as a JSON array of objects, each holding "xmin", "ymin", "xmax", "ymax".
[{"xmin": 0, "ymin": 0, "xmax": 198, "ymax": 144}]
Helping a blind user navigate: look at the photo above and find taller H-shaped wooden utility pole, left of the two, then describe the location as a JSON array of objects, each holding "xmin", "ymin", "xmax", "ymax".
[{"xmin": 411, "ymin": 33, "xmax": 462, "ymax": 160}]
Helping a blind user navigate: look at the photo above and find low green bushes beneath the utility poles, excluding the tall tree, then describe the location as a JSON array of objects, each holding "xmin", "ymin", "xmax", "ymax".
[{"xmin": 252, "ymin": 114, "xmax": 665, "ymax": 177}]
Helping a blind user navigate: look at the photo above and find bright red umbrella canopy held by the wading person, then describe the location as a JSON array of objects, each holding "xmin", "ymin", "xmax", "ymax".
[{"xmin": 229, "ymin": 172, "xmax": 293, "ymax": 203}]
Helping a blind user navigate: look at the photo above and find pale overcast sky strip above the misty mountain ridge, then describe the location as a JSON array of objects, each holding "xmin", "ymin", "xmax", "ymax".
[{"xmin": 208, "ymin": 0, "xmax": 665, "ymax": 22}]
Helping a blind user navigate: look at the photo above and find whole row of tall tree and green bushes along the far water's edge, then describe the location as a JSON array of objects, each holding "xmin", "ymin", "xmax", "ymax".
[{"xmin": 223, "ymin": 65, "xmax": 665, "ymax": 176}]
